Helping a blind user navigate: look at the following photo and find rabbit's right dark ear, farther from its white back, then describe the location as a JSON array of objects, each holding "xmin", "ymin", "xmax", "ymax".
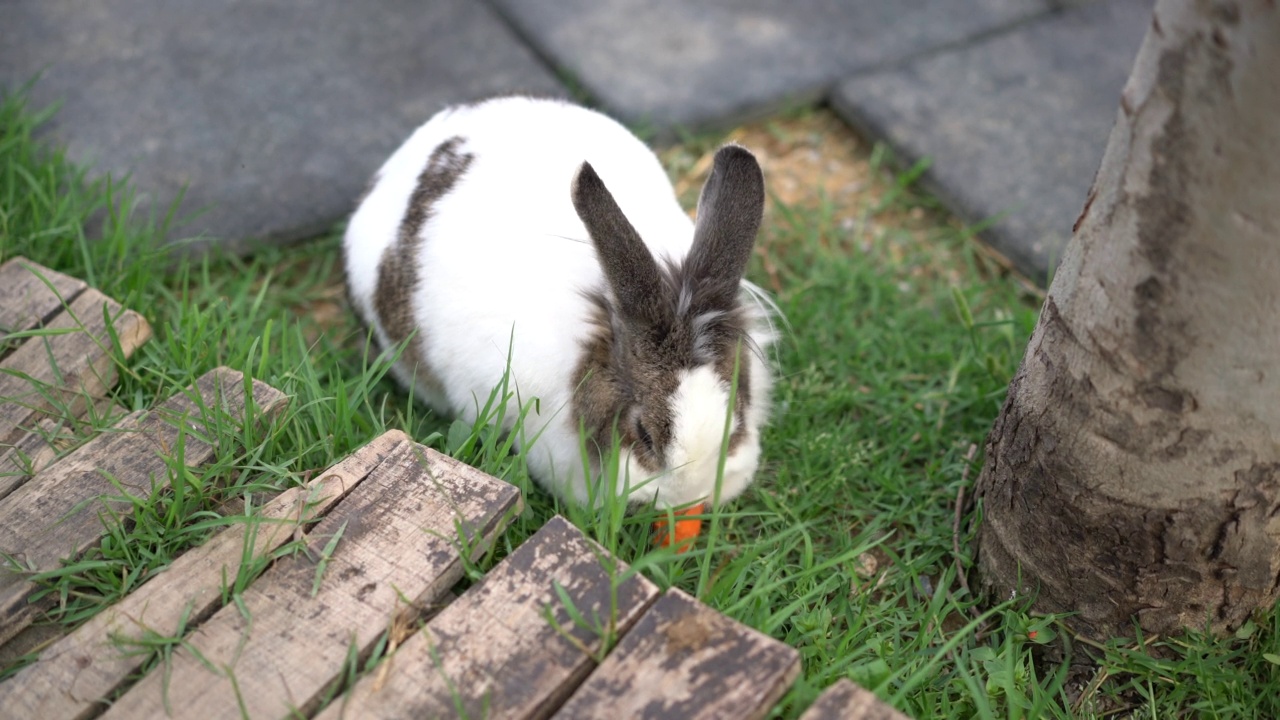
[{"xmin": 685, "ymin": 145, "xmax": 764, "ymax": 307}]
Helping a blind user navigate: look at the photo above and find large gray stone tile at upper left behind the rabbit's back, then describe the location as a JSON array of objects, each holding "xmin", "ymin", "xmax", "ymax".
[{"xmin": 0, "ymin": 0, "xmax": 563, "ymax": 247}]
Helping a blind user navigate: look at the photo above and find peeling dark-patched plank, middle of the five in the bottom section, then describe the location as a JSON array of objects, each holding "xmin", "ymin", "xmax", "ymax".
[{"xmin": 319, "ymin": 518, "xmax": 658, "ymax": 720}]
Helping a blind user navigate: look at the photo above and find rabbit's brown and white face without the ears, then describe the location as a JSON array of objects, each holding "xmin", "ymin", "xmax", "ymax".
[{"xmin": 572, "ymin": 288, "xmax": 768, "ymax": 507}]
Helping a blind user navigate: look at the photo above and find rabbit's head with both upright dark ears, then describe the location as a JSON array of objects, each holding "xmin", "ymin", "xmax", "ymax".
[{"xmin": 571, "ymin": 145, "xmax": 768, "ymax": 506}]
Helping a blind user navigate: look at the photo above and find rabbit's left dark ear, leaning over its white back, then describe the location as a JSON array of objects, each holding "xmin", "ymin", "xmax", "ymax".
[{"xmin": 572, "ymin": 163, "xmax": 663, "ymax": 325}]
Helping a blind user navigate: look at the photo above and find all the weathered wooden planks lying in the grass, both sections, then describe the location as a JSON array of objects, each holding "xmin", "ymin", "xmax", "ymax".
[{"xmin": 0, "ymin": 257, "xmax": 902, "ymax": 720}]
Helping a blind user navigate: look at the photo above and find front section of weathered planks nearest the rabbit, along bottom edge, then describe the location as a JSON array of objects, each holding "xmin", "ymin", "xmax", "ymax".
[{"xmin": 0, "ymin": 430, "xmax": 901, "ymax": 720}]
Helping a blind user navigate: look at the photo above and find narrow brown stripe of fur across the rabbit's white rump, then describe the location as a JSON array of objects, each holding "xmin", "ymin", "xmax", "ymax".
[{"xmin": 374, "ymin": 137, "xmax": 475, "ymax": 388}]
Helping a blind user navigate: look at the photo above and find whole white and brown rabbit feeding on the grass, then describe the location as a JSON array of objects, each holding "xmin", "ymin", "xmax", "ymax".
[{"xmin": 343, "ymin": 96, "xmax": 778, "ymax": 509}]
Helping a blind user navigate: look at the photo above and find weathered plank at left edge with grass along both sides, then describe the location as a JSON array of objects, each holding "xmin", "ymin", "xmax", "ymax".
[{"xmin": 0, "ymin": 366, "xmax": 287, "ymax": 643}]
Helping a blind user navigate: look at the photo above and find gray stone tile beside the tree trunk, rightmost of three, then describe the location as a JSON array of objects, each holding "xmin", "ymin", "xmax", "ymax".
[{"xmin": 832, "ymin": 0, "xmax": 1152, "ymax": 283}]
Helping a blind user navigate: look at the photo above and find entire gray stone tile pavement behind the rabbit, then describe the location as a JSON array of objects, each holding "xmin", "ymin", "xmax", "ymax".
[{"xmin": 0, "ymin": 0, "xmax": 1152, "ymax": 282}]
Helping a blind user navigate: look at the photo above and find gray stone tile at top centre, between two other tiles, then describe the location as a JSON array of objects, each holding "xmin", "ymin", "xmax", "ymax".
[{"xmin": 493, "ymin": 0, "xmax": 1053, "ymax": 129}]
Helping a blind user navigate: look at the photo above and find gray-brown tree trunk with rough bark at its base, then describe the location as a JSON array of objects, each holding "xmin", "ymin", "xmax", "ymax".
[{"xmin": 977, "ymin": 0, "xmax": 1280, "ymax": 638}]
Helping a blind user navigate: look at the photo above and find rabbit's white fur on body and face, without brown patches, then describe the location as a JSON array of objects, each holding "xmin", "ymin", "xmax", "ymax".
[{"xmin": 344, "ymin": 97, "xmax": 771, "ymax": 505}]
